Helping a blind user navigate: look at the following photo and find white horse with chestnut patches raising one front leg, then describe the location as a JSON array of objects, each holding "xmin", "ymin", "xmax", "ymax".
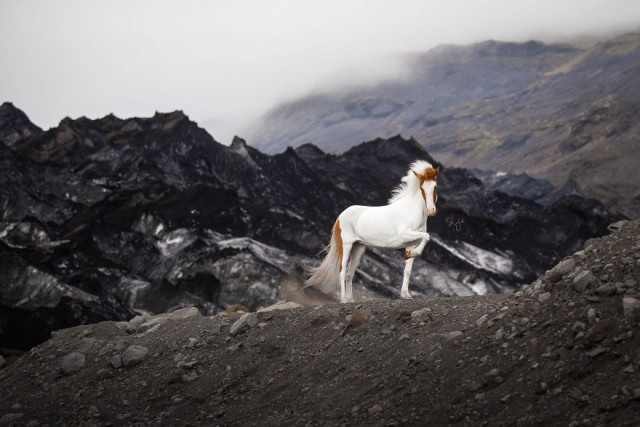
[{"xmin": 305, "ymin": 160, "xmax": 440, "ymax": 302}]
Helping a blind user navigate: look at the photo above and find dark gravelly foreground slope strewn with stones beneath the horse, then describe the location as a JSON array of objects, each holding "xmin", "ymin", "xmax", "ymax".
[{"xmin": 0, "ymin": 222, "xmax": 640, "ymax": 426}]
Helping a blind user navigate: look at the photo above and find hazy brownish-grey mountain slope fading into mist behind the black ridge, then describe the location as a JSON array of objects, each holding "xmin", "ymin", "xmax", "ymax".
[{"xmin": 248, "ymin": 34, "xmax": 640, "ymax": 217}]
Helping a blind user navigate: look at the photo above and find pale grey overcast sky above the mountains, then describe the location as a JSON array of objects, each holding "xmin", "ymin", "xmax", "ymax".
[{"xmin": 0, "ymin": 0, "xmax": 640, "ymax": 143}]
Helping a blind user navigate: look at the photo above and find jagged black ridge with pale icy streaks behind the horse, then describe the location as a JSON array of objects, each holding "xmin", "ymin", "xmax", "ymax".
[{"xmin": 0, "ymin": 104, "xmax": 619, "ymax": 350}]
